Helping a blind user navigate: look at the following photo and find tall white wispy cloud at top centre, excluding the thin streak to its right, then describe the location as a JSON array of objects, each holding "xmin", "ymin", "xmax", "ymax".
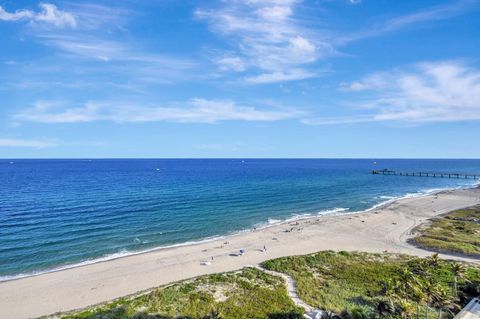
[{"xmin": 195, "ymin": 0, "xmax": 332, "ymax": 83}]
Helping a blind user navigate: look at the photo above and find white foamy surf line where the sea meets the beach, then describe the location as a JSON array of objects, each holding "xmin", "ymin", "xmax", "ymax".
[{"xmin": 0, "ymin": 183, "xmax": 474, "ymax": 284}]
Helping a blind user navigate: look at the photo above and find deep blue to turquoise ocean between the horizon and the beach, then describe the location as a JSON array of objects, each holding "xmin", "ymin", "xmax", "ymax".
[{"xmin": 0, "ymin": 159, "xmax": 480, "ymax": 279}]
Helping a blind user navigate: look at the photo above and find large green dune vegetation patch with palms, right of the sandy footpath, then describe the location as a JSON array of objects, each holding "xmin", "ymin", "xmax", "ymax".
[{"xmin": 264, "ymin": 251, "xmax": 480, "ymax": 319}]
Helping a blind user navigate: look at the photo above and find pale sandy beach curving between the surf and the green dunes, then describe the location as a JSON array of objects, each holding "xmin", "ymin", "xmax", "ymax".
[{"xmin": 0, "ymin": 188, "xmax": 480, "ymax": 318}]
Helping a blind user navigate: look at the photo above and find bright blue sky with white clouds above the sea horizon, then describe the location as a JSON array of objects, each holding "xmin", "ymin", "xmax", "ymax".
[{"xmin": 0, "ymin": 0, "xmax": 480, "ymax": 158}]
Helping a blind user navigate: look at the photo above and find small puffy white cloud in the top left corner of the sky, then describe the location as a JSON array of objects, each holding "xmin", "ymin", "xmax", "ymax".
[{"xmin": 0, "ymin": 3, "xmax": 77, "ymax": 28}]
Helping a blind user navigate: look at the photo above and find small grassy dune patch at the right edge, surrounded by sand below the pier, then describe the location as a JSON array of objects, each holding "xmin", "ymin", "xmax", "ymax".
[{"xmin": 412, "ymin": 206, "xmax": 480, "ymax": 257}]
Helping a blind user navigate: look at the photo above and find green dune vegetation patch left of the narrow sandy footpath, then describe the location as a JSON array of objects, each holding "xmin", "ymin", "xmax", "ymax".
[{"xmin": 57, "ymin": 268, "xmax": 303, "ymax": 319}]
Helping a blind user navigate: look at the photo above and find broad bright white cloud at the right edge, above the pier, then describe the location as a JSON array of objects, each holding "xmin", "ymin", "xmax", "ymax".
[{"xmin": 304, "ymin": 61, "xmax": 480, "ymax": 125}]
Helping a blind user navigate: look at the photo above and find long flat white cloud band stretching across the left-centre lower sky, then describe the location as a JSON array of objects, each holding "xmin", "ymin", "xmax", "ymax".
[{"xmin": 14, "ymin": 98, "xmax": 302, "ymax": 123}]
